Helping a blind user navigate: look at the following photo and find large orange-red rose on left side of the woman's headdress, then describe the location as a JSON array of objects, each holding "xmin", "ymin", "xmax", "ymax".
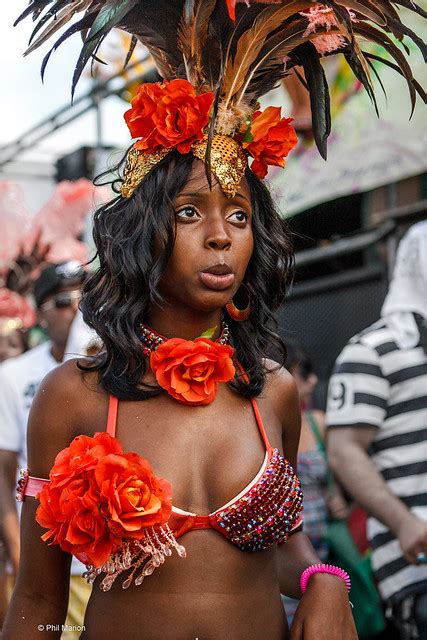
[{"xmin": 124, "ymin": 80, "xmax": 214, "ymax": 153}]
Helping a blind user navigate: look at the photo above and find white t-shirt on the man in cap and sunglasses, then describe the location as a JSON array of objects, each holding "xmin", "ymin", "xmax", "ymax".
[{"xmin": 0, "ymin": 342, "xmax": 86, "ymax": 575}]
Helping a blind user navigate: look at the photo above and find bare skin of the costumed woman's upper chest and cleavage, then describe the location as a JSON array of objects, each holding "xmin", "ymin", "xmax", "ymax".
[{"xmin": 83, "ymin": 388, "xmax": 281, "ymax": 514}]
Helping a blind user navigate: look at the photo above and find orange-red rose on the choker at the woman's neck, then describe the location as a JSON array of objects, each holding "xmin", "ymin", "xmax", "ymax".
[{"xmin": 150, "ymin": 337, "xmax": 236, "ymax": 406}]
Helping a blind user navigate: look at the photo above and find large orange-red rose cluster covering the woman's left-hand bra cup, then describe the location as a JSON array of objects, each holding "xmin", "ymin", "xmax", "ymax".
[{"xmin": 36, "ymin": 433, "xmax": 172, "ymax": 567}]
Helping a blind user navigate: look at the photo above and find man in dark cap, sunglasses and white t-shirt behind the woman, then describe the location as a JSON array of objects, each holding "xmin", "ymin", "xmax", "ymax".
[{"xmin": 0, "ymin": 261, "xmax": 86, "ymax": 636}]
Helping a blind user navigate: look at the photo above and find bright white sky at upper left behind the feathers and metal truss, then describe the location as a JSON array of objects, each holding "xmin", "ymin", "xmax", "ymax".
[{"xmin": 0, "ymin": 0, "xmax": 129, "ymax": 160}]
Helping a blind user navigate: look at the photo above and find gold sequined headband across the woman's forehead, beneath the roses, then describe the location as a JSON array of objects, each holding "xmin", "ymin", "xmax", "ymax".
[{"xmin": 120, "ymin": 134, "xmax": 248, "ymax": 198}]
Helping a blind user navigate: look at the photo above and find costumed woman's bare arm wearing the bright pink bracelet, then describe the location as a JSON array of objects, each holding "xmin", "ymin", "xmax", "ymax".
[{"xmin": 272, "ymin": 370, "xmax": 357, "ymax": 640}]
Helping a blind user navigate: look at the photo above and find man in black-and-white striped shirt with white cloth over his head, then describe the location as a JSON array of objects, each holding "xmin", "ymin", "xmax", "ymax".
[{"xmin": 327, "ymin": 221, "xmax": 427, "ymax": 640}]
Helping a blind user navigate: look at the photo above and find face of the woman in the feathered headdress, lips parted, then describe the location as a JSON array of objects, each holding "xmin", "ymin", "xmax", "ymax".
[{"xmin": 160, "ymin": 160, "xmax": 253, "ymax": 311}]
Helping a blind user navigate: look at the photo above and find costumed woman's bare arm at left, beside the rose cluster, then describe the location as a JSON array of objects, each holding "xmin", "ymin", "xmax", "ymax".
[{"xmin": 2, "ymin": 362, "xmax": 84, "ymax": 640}]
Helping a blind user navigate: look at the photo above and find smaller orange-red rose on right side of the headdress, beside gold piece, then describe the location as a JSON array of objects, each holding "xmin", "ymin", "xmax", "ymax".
[{"xmin": 242, "ymin": 107, "xmax": 298, "ymax": 178}]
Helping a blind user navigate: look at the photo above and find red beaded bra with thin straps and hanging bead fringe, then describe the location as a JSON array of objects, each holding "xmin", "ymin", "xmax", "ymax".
[{"xmin": 17, "ymin": 388, "xmax": 302, "ymax": 591}]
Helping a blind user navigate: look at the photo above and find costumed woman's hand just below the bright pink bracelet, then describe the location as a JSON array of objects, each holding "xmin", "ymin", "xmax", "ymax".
[{"xmin": 290, "ymin": 573, "xmax": 357, "ymax": 640}]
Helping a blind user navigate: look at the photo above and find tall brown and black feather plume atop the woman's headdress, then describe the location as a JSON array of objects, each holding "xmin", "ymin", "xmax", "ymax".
[{"xmin": 17, "ymin": 0, "xmax": 427, "ymax": 190}]
